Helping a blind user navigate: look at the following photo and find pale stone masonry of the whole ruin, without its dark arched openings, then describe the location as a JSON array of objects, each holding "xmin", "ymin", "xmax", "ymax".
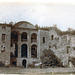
[{"xmin": 0, "ymin": 23, "xmax": 75, "ymax": 67}]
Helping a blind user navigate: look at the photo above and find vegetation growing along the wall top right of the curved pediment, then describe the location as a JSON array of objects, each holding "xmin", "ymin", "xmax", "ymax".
[{"xmin": 35, "ymin": 24, "xmax": 75, "ymax": 35}]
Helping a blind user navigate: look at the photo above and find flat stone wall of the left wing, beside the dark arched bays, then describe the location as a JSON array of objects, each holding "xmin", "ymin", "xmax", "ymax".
[{"xmin": 0, "ymin": 25, "xmax": 11, "ymax": 65}]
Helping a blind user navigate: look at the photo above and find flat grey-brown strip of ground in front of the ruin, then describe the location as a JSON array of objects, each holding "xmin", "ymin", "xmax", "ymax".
[{"xmin": 0, "ymin": 67, "xmax": 75, "ymax": 75}]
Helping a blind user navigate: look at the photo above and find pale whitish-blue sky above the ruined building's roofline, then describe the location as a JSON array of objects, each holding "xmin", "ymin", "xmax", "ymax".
[{"xmin": 0, "ymin": 0, "xmax": 75, "ymax": 31}]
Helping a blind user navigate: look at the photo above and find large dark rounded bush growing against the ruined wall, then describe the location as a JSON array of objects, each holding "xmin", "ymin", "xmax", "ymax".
[{"xmin": 41, "ymin": 50, "xmax": 63, "ymax": 67}]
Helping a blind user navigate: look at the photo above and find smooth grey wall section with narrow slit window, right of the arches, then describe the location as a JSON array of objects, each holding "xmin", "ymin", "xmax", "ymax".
[{"xmin": 39, "ymin": 30, "xmax": 49, "ymax": 56}]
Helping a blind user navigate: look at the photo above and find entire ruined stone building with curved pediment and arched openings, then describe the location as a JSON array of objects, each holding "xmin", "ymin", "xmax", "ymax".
[{"xmin": 0, "ymin": 21, "xmax": 75, "ymax": 67}]
